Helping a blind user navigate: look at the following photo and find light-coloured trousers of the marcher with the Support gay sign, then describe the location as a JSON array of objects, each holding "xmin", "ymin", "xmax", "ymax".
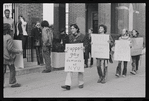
[{"xmin": 65, "ymin": 72, "xmax": 84, "ymax": 86}]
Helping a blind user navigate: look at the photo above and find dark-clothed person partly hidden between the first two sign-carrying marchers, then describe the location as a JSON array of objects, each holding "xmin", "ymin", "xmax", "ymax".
[{"xmin": 84, "ymin": 28, "xmax": 93, "ymax": 68}]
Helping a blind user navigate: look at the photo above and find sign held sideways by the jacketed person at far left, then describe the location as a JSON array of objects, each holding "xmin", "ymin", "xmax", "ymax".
[{"xmin": 13, "ymin": 40, "xmax": 24, "ymax": 68}]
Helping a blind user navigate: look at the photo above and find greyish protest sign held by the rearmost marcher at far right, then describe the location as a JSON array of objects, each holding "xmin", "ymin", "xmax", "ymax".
[{"xmin": 131, "ymin": 38, "xmax": 143, "ymax": 56}]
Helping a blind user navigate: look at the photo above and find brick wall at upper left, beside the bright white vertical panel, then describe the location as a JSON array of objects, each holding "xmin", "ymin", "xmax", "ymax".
[{"xmin": 16, "ymin": 3, "xmax": 43, "ymax": 35}]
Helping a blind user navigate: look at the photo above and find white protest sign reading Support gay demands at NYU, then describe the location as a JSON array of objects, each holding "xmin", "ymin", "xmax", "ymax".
[{"xmin": 65, "ymin": 43, "xmax": 84, "ymax": 72}]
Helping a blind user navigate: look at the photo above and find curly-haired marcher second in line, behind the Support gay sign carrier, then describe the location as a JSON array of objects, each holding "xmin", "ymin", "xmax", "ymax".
[{"xmin": 96, "ymin": 25, "xmax": 113, "ymax": 83}]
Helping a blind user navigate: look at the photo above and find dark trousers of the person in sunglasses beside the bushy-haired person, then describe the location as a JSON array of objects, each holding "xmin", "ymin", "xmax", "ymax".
[{"xmin": 35, "ymin": 46, "xmax": 43, "ymax": 65}]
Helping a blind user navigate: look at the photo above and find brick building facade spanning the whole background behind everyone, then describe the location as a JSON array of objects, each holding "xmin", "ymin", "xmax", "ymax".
[{"xmin": 5, "ymin": 3, "xmax": 146, "ymax": 62}]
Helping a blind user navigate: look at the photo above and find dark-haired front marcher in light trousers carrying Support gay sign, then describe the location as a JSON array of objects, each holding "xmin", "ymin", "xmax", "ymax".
[{"xmin": 61, "ymin": 24, "xmax": 84, "ymax": 90}]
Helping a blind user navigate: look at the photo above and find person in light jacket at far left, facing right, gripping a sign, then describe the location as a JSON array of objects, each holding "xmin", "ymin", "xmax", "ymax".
[{"xmin": 3, "ymin": 23, "xmax": 22, "ymax": 87}]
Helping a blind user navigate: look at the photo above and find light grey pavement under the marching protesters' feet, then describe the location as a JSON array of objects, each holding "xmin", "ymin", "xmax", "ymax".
[{"xmin": 3, "ymin": 56, "xmax": 146, "ymax": 98}]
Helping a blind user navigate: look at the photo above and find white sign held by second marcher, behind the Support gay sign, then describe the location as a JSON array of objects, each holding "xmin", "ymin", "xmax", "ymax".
[{"xmin": 91, "ymin": 34, "xmax": 109, "ymax": 59}]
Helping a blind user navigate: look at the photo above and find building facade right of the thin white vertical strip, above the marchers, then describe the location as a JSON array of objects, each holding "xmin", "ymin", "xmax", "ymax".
[{"xmin": 69, "ymin": 3, "xmax": 146, "ymax": 39}]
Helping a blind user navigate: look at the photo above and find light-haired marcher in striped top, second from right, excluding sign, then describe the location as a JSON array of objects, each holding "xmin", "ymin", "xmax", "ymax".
[{"xmin": 115, "ymin": 29, "xmax": 131, "ymax": 77}]
